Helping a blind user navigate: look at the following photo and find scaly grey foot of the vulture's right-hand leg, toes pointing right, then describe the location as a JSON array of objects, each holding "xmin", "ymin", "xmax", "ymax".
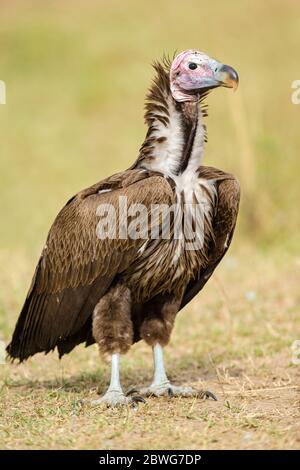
[{"xmin": 126, "ymin": 382, "xmax": 217, "ymax": 401}]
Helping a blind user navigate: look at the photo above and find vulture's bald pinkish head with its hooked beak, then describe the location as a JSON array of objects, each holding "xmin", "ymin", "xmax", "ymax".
[{"xmin": 170, "ymin": 49, "xmax": 239, "ymax": 101}]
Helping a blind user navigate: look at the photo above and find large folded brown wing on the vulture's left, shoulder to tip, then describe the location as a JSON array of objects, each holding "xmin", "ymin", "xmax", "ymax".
[{"xmin": 7, "ymin": 170, "xmax": 173, "ymax": 361}]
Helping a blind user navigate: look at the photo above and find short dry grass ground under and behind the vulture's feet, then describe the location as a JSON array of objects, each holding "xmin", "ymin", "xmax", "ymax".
[{"xmin": 0, "ymin": 246, "xmax": 300, "ymax": 449}]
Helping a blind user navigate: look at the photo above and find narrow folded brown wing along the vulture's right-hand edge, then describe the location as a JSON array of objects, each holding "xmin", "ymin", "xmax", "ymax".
[{"xmin": 180, "ymin": 167, "xmax": 240, "ymax": 308}]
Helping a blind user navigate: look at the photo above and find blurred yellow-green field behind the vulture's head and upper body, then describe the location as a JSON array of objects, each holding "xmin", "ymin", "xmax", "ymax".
[{"xmin": 0, "ymin": 0, "xmax": 300, "ymax": 258}]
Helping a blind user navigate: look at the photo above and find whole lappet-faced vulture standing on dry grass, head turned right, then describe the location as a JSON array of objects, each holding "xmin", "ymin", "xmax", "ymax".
[{"xmin": 7, "ymin": 50, "xmax": 240, "ymax": 406}]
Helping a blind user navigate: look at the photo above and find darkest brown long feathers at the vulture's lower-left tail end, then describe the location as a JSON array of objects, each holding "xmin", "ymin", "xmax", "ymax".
[{"xmin": 6, "ymin": 277, "xmax": 111, "ymax": 362}]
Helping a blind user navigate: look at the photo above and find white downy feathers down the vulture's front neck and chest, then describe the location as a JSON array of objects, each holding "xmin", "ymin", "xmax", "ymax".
[{"xmin": 138, "ymin": 97, "xmax": 216, "ymax": 264}]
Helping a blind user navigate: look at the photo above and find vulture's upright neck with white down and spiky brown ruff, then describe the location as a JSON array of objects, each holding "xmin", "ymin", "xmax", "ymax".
[{"xmin": 134, "ymin": 64, "xmax": 206, "ymax": 179}]
